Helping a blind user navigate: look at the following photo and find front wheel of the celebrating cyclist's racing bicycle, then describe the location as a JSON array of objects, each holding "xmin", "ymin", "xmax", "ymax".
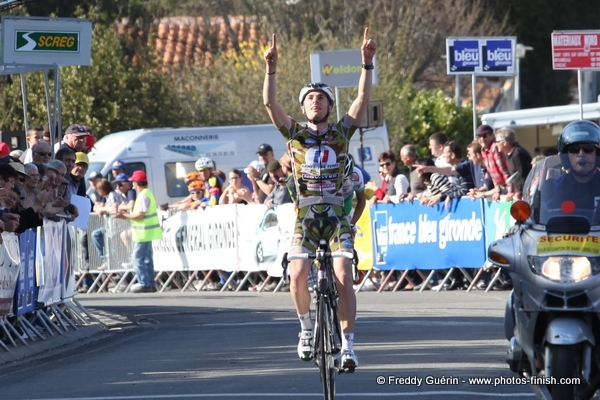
[{"xmin": 315, "ymin": 292, "xmax": 337, "ymax": 400}]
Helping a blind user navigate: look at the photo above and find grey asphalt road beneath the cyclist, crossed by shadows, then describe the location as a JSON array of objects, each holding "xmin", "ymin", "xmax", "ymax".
[{"xmin": 0, "ymin": 291, "xmax": 535, "ymax": 400}]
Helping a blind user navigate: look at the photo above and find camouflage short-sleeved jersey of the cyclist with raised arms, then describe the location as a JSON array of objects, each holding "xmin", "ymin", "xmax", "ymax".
[{"xmin": 279, "ymin": 116, "xmax": 357, "ymax": 208}]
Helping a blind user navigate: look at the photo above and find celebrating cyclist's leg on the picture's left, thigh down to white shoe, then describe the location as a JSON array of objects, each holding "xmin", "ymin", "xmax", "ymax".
[{"xmin": 288, "ymin": 211, "xmax": 315, "ymax": 361}]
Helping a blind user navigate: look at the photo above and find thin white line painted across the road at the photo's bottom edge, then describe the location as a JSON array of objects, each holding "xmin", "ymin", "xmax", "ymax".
[{"xmin": 31, "ymin": 390, "xmax": 535, "ymax": 400}]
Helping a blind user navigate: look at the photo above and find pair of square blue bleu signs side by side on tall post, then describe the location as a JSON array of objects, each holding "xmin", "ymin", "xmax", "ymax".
[{"xmin": 446, "ymin": 37, "xmax": 516, "ymax": 75}]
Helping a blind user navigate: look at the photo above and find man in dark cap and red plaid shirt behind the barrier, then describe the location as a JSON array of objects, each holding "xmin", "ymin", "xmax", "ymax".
[{"xmin": 475, "ymin": 125, "xmax": 513, "ymax": 201}]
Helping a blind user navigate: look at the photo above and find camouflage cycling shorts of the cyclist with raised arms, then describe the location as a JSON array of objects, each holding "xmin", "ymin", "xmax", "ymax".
[{"xmin": 289, "ymin": 204, "xmax": 354, "ymax": 254}]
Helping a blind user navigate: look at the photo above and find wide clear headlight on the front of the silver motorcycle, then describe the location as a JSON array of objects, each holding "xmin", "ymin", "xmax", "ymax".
[{"xmin": 528, "ymin": 256, "xmax": 600, "ymax": 283}]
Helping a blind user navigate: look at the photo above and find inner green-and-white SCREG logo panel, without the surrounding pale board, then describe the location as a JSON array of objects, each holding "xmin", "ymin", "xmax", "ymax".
[{"xmin": 15, "ymin": 31, "xmax": 79, "ymax": 53}]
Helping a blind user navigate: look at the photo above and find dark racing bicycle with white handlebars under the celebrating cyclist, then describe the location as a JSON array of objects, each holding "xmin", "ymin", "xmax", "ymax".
[{"xmin": 282, "ymin": 239, "xmax": 356, "ymax": 400}]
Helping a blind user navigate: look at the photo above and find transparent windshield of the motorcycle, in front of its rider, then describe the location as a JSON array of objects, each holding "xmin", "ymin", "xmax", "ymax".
[{"xmin": 523, "ymin": 155, "xmax": 600, "ymax": 226}]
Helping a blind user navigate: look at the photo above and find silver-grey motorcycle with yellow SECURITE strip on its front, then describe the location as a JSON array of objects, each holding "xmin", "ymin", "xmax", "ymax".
[{"xmin": 488, "ymin": 154, "xmax": 600, "ymax": 400}]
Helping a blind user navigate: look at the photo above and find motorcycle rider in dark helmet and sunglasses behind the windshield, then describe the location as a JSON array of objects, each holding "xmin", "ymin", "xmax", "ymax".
[{"xmin": 550, "ymin": 121, "xmax": 600, "ymax": 212}]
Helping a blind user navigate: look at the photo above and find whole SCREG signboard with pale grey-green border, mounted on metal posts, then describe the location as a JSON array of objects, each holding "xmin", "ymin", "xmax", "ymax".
[{"xmin": 1, "ymin": 16, "xmax": 92, "ymax": 66}]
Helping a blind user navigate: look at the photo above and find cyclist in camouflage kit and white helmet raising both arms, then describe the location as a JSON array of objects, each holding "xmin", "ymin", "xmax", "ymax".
[{"xmin": 263, "ymin": 28, "xmax": 376, "ymax": 370}]
